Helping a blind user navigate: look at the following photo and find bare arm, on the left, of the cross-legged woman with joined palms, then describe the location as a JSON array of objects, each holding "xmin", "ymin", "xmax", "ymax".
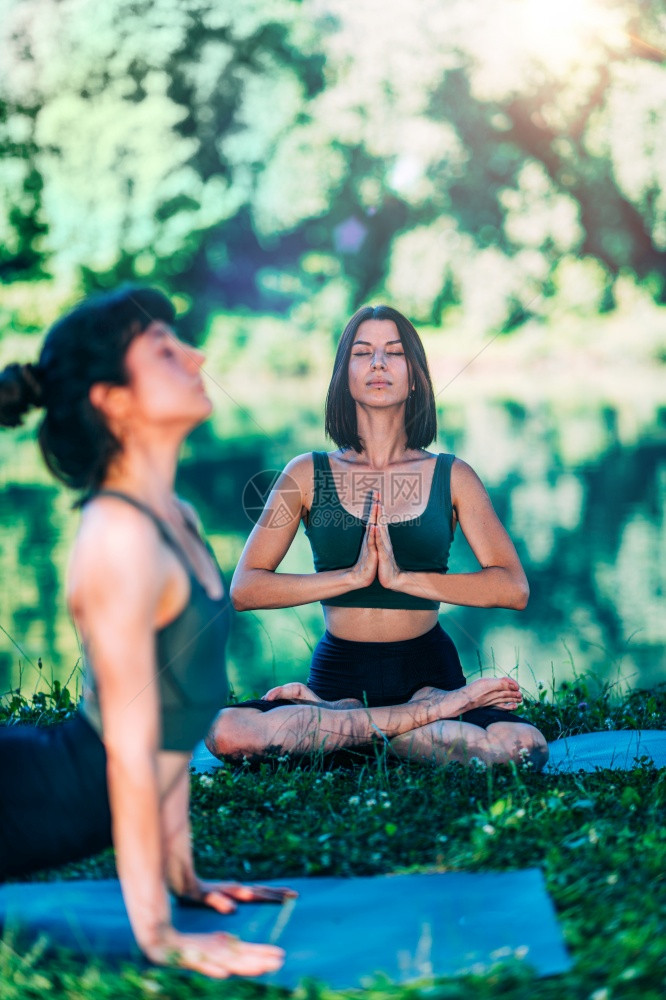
[{"xmin": 231, "ymin": 455, "xmax": 377, "ymax": 611}]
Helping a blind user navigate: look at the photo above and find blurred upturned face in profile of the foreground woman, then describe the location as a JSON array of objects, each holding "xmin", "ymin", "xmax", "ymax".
[{"xmin": 111, "ymin": 320, "xmax": 212, "ymax": 431}]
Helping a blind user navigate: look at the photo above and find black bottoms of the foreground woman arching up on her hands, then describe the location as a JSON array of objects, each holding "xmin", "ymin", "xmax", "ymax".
[{"xmin": 0, "ymin": 713, "xmax": 111, "ymax": 879}]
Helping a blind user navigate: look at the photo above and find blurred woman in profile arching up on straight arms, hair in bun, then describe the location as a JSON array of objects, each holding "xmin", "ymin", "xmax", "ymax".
[{"xmin": 0, "ymin": 289, "xmax": 289, "ymax": 978}]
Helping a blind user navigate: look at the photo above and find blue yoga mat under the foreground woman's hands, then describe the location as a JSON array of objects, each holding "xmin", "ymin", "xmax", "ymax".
[{"xmin": 0, "ymin": 868, "xmax": 570, "ymax": 989}]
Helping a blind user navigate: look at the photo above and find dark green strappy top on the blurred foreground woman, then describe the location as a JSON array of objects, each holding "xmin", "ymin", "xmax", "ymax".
[{"xmin": 79, "ymin": 490, "xmax": 232, "ymax": 753}]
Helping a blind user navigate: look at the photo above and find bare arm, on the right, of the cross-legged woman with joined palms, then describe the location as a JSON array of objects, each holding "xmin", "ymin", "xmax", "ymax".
[{"xmin": 373, "ymin": 459, "xmax": 529, "ymax": 611}]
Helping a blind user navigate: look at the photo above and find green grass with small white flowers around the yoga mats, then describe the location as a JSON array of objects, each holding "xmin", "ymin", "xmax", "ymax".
[{"xmin": 0, "ymin": 679, "xmax": 666, "ymax": 1000}]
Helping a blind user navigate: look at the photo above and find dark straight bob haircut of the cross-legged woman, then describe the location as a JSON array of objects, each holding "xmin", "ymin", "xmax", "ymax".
[{"xmin": 325, "ymin": 306, "xmax": 437, "ymax": 452}]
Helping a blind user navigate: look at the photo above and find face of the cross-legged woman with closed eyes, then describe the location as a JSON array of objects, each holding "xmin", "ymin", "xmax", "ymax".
[{"xmin": 349, "ymin": 319, "xmax": 410, "ymax": 406}]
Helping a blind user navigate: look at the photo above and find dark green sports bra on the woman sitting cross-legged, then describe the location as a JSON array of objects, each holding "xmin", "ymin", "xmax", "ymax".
[{"xmin": 305, "ymin": 451, "xmax": 455, "ymax": 611}]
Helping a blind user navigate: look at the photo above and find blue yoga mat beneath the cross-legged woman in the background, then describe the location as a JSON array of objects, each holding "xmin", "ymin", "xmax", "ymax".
[{"xmin": 191, "ymin": 729, "xmax": 666, "ymax": 774}]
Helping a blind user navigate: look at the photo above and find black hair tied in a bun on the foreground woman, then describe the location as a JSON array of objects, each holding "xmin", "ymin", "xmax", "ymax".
[{"xmin": 0, "ymin": 285, "xmax": 175, "ymax": 490}]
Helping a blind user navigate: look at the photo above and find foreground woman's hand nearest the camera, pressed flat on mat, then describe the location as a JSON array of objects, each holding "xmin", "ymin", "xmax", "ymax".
[{"xmin": 143, "ymin": 926, "xmax": 285, "ymax": 979}]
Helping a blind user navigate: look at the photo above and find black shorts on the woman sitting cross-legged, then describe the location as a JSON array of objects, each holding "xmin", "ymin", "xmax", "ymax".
[{"xmin": 234, "ymin": 623, "xmax": 528, "ymax": 729}]
